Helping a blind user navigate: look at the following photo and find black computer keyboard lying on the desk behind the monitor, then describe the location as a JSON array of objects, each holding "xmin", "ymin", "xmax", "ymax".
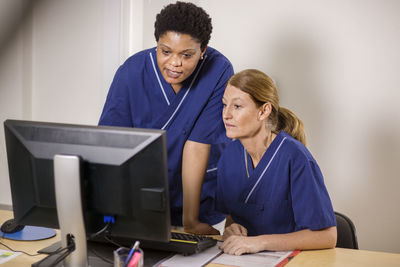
[{"xmin": 140, "ymin": 232, "xmax": 217, "ymax": 256}]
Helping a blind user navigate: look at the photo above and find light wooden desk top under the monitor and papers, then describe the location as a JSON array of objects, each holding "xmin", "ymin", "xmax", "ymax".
[{"xmin": 0, "ymin": 210, "xmax": 400, "ymax": 267}]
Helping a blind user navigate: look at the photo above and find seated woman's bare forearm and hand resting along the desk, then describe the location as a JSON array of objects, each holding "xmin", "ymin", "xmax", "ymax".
[{"xmin": 220, "ymin": 226, "xmax": 337, "ymax": 255}]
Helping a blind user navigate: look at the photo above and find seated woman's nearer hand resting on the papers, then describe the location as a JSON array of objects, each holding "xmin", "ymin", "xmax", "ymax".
[{"xmin": 219, "ymin": 235, "xmax": 263, "ymax": 256}]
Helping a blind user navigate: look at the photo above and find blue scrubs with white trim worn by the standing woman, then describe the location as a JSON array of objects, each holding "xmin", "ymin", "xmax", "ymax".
[{"xmin": 99, "ymin": 47, "xmax": 233, "ymax": 226}]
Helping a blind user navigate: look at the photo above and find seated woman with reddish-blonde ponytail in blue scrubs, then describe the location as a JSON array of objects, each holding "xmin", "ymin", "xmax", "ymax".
[{"xmin": 216, "ymin": 69, "xmax": 337, "ymax": 255}]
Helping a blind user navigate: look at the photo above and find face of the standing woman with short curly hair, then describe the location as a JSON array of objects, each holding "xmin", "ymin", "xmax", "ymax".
[{"xmin": 157, "ymin": 31, "xmax": 205, "ymax": 93}]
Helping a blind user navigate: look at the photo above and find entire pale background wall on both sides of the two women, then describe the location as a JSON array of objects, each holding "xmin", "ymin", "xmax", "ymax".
[{"xmin": 0, "ymin": 0, "xmax": 400, "ymax": 253}]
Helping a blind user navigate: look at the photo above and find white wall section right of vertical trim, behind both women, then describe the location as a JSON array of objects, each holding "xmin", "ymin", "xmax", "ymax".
[{"xmin": 143, "ymin": 0, "xmax": 400, "ymax": 253}]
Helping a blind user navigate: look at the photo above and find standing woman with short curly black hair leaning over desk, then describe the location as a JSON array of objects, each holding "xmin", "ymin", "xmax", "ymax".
[{"xmin": 99, "ymin": 2, "xmax": 233, "ymax": 234}]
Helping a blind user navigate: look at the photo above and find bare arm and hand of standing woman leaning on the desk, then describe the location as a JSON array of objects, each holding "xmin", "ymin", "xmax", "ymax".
[{"xmin": 182, "ymin": 140, "xmax": 219, "ymax": 235}]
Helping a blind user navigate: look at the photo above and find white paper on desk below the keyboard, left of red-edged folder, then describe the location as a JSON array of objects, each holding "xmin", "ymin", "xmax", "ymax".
[{"xmin": 159, "ymin": 245, "xmax": 222, "ymax": 267}]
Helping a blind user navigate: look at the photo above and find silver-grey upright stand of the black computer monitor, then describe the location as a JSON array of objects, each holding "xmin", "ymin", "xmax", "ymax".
[{"xmin": 54, "ymin": 155, "xmax": 88, "ymax": 267}]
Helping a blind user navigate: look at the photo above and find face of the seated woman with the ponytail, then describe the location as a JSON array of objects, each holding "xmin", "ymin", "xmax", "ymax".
[{"xmin": 222, "ymin": 84, "xmax": 266, "ymax": 140}]
